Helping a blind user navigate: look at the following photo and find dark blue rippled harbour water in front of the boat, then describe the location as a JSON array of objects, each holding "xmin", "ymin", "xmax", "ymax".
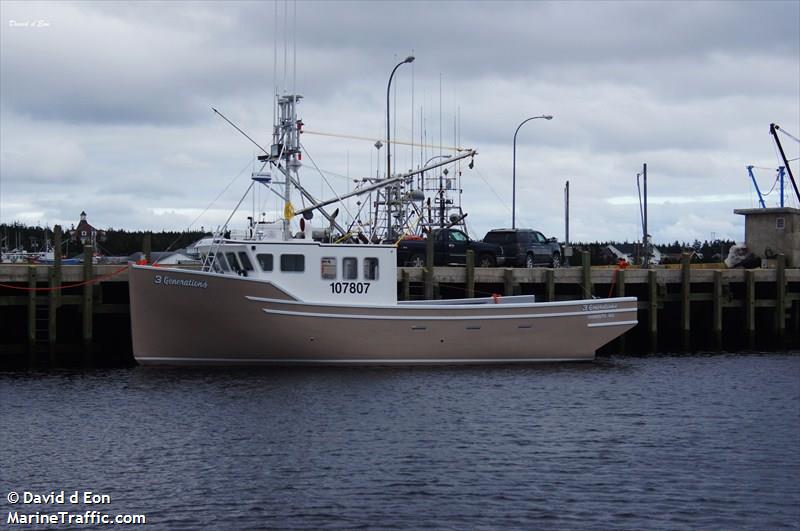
[{"xmin": 0, "ymin": 353, "xmax": 800, "ymax": 529}]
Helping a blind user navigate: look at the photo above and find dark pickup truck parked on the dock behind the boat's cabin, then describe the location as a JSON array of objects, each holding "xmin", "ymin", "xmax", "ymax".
[{"xmin": 397, "ymin": 229, "xmax": 504, "ymax": 267}]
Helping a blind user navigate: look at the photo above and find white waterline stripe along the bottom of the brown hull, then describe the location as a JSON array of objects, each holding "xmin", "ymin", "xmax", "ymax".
[{"xmin": 135, "ymin": 354, "xmax": 594, "ymax": 365}]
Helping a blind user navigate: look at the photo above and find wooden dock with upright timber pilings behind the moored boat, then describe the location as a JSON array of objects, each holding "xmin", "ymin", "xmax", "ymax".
[{"xmin": 0, "ymin": 250, "xmax": 800, "ymax": 363}]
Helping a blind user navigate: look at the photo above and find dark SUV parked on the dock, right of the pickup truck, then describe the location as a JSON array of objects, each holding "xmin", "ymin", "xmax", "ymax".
[{"xmin": 483, "ymin": 229, "xmax": 562, "ymax": 267}]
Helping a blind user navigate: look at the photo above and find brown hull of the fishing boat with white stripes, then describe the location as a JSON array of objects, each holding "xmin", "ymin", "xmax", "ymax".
[{"xmin": 130, "ymin": 267, "xmax": 636, "ymax": 365}]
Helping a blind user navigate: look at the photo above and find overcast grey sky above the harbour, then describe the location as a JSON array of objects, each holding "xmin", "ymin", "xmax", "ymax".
[{"xmin": 0, "ymin": 0, "xmax": 800, "ymax": 242}]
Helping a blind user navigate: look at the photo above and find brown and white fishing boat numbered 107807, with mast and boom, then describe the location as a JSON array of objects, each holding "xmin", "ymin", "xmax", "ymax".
[{"xmin": 130, "ymin": 91, "xmax": 637, "ymax": 365}]
